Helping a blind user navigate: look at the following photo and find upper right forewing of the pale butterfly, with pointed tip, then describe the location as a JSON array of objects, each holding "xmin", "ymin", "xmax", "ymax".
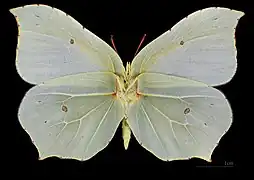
[{"xmin": 131, "ymin": 8, "xmax": 244, "ymax": 86}]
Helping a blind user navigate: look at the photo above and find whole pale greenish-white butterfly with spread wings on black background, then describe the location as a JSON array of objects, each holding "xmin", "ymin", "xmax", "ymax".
[{"xmin": 10, "ymin": 5, "xmax": 244, "ymax": 161}]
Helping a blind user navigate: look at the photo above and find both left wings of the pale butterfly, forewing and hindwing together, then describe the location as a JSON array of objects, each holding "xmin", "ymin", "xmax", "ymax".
[{"xmin": 10, "ymin": 5, "xmax": 124, "ymax": 160}]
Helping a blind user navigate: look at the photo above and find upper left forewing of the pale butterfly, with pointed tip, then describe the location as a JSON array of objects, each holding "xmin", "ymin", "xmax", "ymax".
[{"xmin": 10, "ymin": 5, "xmax": 124, "ymax": 84}]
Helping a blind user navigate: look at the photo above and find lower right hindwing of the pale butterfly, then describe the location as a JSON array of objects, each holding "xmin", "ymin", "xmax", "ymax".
[{"xmin": 127, "ymin": 73, "xmax": 232, "ymax": 161}]
